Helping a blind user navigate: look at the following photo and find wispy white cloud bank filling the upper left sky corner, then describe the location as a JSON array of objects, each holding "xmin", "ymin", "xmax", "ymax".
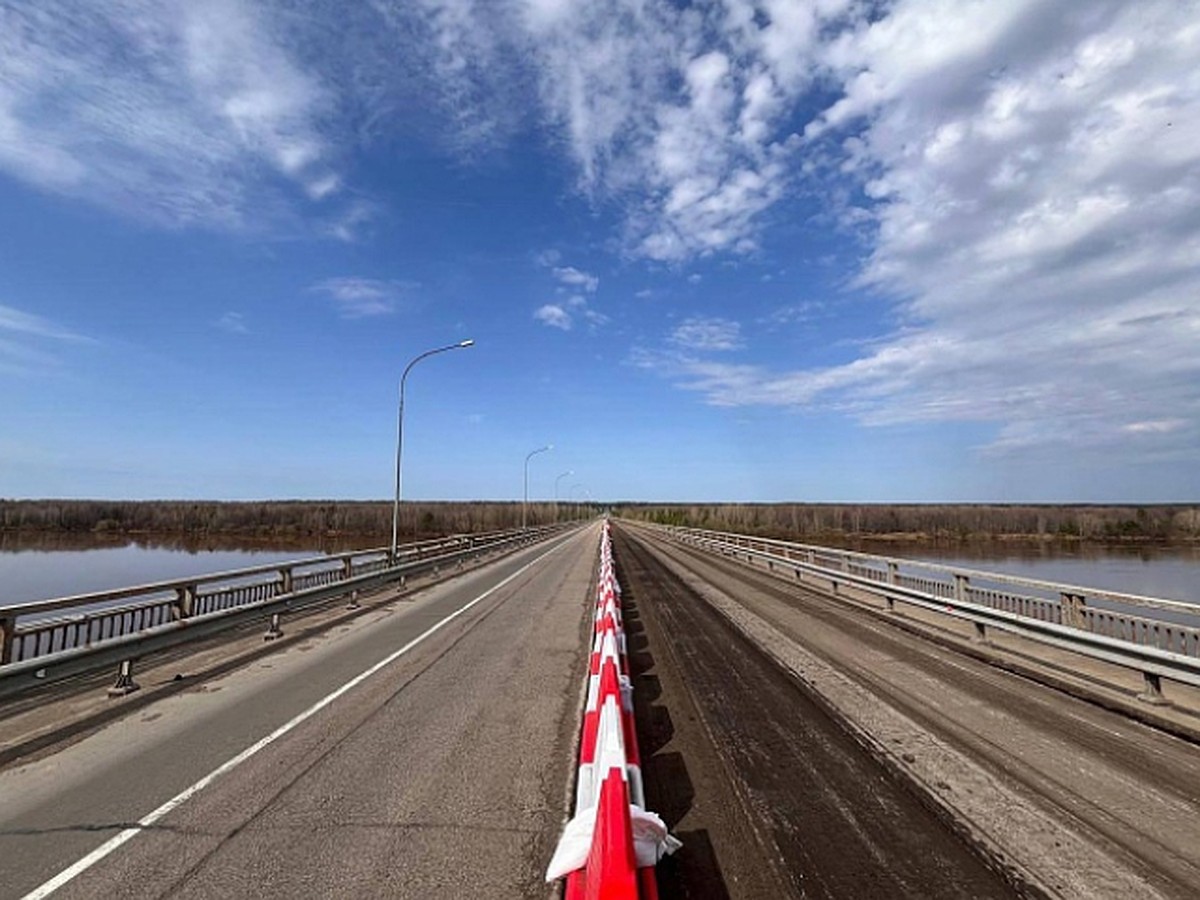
[{"xmin": 0, "ymin": 0, "xmax": 340, "ymax": 229}]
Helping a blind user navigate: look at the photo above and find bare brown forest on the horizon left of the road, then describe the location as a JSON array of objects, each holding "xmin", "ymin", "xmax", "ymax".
[{"xmin": 0, "ymin": 499, "xmax": 592, "ymax": 542}]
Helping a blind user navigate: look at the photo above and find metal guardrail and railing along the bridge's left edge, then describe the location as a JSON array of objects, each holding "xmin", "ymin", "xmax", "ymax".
[{"xmin": 0, "ymin": 524, "xmax": 564, "ymax": 697}]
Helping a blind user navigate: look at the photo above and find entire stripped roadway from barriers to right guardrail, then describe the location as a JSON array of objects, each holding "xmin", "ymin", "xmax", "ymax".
[{"xmin": 616, "ymin": 527, "xmax": 1200, "ymax": 898}]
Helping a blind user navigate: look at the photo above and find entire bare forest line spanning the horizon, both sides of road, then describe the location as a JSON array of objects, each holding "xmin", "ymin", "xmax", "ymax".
[{"xmin": 0, "ymin": 499, "xmax": 1200, "ymax": 542}]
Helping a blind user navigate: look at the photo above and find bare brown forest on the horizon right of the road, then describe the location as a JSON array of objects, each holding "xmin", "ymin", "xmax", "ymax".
[{"xmin": 618, "ymin": 503, "xmax": 1200, "ymax": 541}]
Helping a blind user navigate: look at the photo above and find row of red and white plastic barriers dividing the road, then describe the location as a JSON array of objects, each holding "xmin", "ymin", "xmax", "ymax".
[{"xmin": 546, "ymin": 522, "xmax": 680, "ymax": 900}]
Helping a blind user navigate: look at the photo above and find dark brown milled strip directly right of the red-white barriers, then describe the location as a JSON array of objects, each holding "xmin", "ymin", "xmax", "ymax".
[{"xmin": 616, "ymin": 528, "xmax": 1013, "ymax": 900}]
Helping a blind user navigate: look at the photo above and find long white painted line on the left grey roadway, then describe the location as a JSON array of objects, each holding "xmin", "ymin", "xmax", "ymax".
[{"xmin": 22, "ymin": 535, "xmax": 575, "ymax": 900}]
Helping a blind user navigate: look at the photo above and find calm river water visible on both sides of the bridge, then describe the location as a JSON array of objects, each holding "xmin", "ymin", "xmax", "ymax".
[{"xmin": 0, "ymin": 535, "xmax": 1200, "ymax": 606}]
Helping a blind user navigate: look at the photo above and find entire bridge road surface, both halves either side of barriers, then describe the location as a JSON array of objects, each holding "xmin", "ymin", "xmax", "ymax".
[{"xmin": 0, "ymin": 523, "xmax": 1200, "ymax": 900}]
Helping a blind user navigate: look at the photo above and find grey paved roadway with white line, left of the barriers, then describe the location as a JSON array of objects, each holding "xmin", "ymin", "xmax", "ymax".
[{"xmin": 0, "ymin": 527, "xmax": 599, "ymax": 900}]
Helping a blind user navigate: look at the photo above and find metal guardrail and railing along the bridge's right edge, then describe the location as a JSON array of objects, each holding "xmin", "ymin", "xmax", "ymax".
[{"xmin": 631, "ymin": 523, "xmax": 1200, "ymax": 703}]
